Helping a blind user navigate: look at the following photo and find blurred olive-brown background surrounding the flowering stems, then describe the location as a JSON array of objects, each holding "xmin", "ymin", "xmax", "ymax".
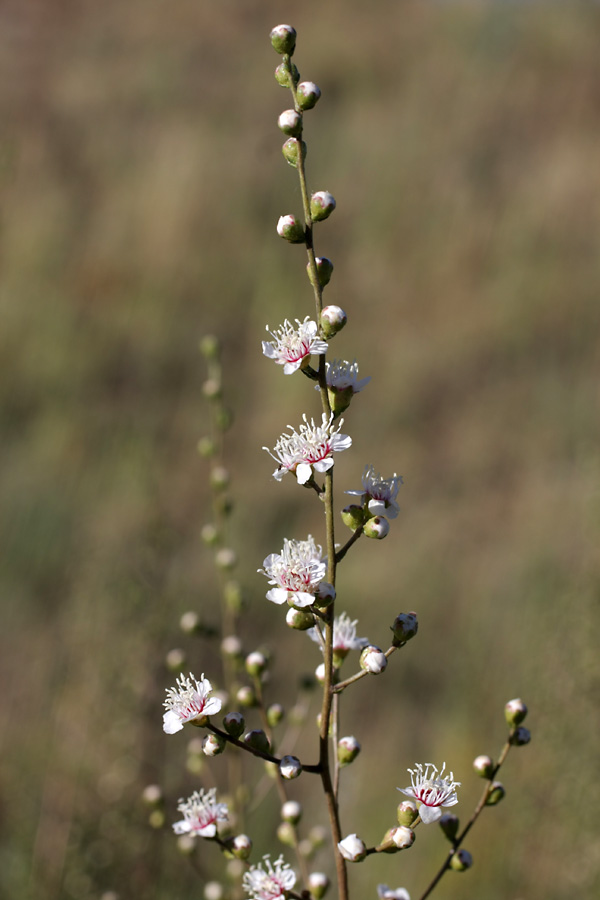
[{"xmin": 0, "ymin": 0, "xmax": 600, "ymax": 900}]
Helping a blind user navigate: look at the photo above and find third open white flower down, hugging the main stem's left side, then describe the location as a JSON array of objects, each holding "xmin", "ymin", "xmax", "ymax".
[{"xmin": 258, "ymin": 534, "xmax": 327, "ymax": 607}]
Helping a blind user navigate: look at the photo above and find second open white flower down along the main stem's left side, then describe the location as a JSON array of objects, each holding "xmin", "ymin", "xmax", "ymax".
[{"xmin": 263, "ymin": 413, "xmax": 352, "ymax": 484}]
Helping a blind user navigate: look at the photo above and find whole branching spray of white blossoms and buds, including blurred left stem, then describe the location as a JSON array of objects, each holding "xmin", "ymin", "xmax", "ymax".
[{"xmin": 154, "ymin": 19, "xmax": 529, "ymax": 900}]
